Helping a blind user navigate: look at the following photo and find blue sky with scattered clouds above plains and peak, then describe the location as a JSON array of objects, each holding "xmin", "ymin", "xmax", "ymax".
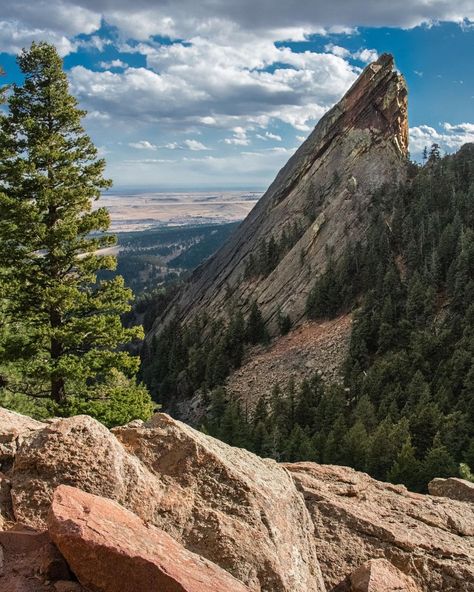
[{"xmin": 0, "ymin": 0, "xmax": 474, "ymax": 191}]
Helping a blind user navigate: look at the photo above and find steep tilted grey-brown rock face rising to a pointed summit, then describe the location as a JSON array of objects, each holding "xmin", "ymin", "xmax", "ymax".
[{"xmin": 148, "ymin": 54, "xmax": 408, "ymax": 339}]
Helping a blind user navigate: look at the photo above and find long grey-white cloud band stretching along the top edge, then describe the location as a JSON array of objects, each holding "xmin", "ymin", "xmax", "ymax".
[{"xmin": 2, "ymin": 0, "xmax": 474, "ymax": 47}]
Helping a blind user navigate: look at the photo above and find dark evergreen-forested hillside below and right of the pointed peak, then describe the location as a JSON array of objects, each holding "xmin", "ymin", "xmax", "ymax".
[{"xmin": 145, "ymin": 144, "xmax": 474, "ymax": 490}]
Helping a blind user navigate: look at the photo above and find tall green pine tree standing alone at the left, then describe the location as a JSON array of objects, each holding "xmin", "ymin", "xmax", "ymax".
[{"xmin": 0, "ymin": 43, "xmax": 151, "ymax": 416}]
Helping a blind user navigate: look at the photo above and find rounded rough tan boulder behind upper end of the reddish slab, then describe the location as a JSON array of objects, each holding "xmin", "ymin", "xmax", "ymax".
[{"xmin": 10, "ymin": 415, "xmax": 163, "ymax": 529}]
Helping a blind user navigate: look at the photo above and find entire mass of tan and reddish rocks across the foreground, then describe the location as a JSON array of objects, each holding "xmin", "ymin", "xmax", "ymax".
[{"xmin": 0, "ymin": 411, "xmax": 474, "ymax": 592}]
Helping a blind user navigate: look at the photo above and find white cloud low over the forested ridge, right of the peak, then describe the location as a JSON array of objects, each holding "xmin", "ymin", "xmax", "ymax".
[{"xmin": 410, "ymin": 123, "xmax": 474, "ymax": 158}]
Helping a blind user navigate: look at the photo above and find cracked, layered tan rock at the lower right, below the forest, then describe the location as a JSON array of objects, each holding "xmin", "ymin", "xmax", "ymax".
[{"xmin": 285, "ymin": 463, "xmax": 474, "ymax": 592}]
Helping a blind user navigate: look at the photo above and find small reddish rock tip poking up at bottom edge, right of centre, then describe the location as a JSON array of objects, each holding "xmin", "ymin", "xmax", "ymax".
[{"xmin": 334, "ymin": 559, "xmax": 420, "ymax": 592}]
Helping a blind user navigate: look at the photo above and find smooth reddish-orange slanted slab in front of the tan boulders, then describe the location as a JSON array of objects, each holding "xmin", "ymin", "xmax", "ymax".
[{"xmin": 48, "ymin": 485, "xmax": 250, "ymax": 592}]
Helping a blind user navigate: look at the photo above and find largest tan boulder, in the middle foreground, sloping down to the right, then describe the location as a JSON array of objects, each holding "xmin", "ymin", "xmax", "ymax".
[{"xmin": 113, "ymin": 413, "xmax": 324, "ymax": 592}]
